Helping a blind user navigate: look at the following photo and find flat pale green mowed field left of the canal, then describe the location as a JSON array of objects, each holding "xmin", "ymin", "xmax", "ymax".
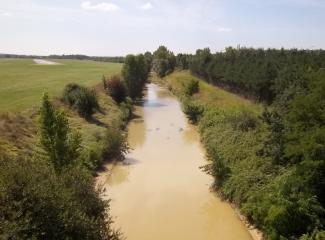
[{"xmin": 0, "ymin": 59, "xmax": 122, "ymax": 112}]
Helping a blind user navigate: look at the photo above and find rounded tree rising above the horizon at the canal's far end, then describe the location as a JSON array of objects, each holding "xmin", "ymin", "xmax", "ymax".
[{"xmin": 152, "ymin": 46, "xmax": 176, "ymax": 77}]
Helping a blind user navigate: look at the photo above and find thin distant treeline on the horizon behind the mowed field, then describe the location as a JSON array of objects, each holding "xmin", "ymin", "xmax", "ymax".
[{"xmin": 0, "ymin": 54, "xmax": 125, "ymax": 63}]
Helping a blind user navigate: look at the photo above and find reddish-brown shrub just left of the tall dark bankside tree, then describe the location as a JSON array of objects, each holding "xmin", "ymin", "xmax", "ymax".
[{"xmin": 106, "ymin": 75, "xmax": 128, "ymax": 103}]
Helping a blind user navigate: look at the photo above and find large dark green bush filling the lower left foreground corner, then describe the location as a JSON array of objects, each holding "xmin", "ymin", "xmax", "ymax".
[{"xmin": 0, "ymin": 156, "xmax": 118, "ymax": 240}]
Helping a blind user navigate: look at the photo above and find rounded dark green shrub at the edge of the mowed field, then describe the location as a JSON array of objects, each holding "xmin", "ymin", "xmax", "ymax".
[{"xmin": 62, "ymin": 83, "xmax": 99, "ymax": 119}]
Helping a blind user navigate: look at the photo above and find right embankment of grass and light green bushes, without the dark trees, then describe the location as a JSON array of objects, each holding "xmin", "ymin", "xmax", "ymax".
[{"xmin": 161, "ymin": 71, "xmax": 264, "ymax": 239}]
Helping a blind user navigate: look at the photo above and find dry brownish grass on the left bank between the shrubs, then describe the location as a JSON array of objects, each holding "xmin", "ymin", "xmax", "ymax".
[{"xmin": 0, "ymin": 88, "xmax": 124, "ymax": 158}]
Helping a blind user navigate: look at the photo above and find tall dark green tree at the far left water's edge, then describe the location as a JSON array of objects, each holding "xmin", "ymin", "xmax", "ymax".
[{"xmin": 122, "ymin": 54, "xmax": 150, "ymax": 99}]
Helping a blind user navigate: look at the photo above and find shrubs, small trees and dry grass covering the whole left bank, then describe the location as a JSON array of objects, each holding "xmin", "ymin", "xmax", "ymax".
[{"xmin": 0, "ymin": 55, "xmax": 148, "ymax": 240}]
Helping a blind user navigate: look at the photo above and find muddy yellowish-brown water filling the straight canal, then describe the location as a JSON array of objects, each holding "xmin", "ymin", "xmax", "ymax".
[{"xmin": 98, "ymin": 84, "xmax": 252, "ymax": 240}]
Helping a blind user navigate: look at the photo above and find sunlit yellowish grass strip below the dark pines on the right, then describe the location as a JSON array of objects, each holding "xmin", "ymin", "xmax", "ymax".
[{"xmin": 166, "ymin": 71, "xmax": 262, "ymax": 113}]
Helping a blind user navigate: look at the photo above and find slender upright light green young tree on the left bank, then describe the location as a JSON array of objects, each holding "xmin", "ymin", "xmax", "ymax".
[{"xmin": 38, "ymin": 93, "xmax": 81, "ymax": 172}]
